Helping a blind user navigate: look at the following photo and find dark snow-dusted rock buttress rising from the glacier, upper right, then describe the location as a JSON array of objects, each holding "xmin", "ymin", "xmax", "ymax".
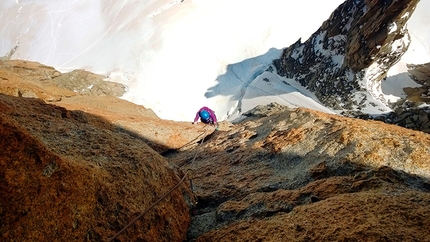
[{"xmin": 275, "ymin": 0, "xmax": 419, "ymax": 115}]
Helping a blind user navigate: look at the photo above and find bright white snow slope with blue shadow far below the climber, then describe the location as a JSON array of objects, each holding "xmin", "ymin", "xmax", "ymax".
[{"xmin": 0, "ymin": 0, "xmax": 430, "ymax": 121}]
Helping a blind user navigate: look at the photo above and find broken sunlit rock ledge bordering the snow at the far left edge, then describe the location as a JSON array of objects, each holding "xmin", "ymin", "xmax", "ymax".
[{"xmin": 0, "ymin": 60, "xmax": 125, "ymax": 102}]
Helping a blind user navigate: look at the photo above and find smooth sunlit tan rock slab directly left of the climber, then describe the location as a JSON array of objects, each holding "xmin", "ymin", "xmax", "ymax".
[{"xmin": 55, "ymin": 95, "xmax": 214, "ymax": 153}]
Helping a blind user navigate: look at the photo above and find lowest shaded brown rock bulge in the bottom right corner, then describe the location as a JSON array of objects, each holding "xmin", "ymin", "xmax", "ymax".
[{"xmin": 196, "ymin": 191, "xmax": 430, "ymax": 241}]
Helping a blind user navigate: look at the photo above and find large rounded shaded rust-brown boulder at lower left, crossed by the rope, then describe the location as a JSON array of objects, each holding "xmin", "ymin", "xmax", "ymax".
[{"xmin": 0, "ymin": 94, "xmax": 195, "ymax": 241}]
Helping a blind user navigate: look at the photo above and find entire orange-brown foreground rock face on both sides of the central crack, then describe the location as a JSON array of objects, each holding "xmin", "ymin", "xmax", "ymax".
[{"xmin": 0, "ymin": 60, "xmax": 430, "ymax": 241}]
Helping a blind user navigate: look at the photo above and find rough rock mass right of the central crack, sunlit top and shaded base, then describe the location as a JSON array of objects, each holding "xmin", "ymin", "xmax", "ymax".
[{"xmin": 170, "ymin": 104, "xmax": 430, "ymax": 241}]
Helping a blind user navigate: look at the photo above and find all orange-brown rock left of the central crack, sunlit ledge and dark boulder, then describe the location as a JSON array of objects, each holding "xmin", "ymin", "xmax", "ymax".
[{"xmin": 0, "ymin": 60, "xmax": 218, "ymax": 241}]
